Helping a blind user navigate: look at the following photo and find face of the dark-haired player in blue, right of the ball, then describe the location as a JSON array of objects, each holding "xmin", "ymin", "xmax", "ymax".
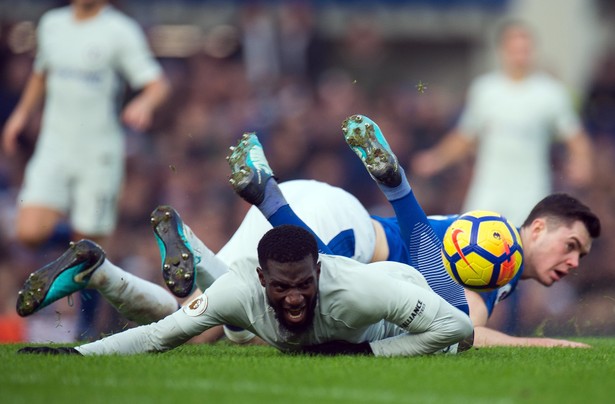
[{"xmin": 526, "ymin": 221, "xmax": 592, "ymax": 286}]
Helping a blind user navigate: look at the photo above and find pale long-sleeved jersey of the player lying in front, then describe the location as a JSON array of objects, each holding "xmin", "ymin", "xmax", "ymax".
[{"xmin": 77, "ymin": 255, "xmax": 472, "ymax": 356}]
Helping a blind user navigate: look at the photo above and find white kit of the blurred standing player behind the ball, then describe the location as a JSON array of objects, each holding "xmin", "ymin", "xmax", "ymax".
[{"xmin": 459, "ymin": 72, "xmax": 581, "ymax": 226}]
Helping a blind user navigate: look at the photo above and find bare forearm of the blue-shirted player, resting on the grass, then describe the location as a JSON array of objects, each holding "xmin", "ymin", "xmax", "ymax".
[{"xmin": 466, "ymin": 290, "xmax": 591, "ymax": 348}]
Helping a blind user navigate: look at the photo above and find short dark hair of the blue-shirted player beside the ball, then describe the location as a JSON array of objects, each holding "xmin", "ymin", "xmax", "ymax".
[{"xmin": 522, "ymin": 193, "xmax": 600, "ymax": 238}]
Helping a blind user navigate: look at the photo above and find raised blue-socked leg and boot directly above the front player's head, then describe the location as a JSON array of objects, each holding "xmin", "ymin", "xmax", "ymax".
[{"xmin": 227, "ymin": 133, "xmax": 333, "ymax": 254}]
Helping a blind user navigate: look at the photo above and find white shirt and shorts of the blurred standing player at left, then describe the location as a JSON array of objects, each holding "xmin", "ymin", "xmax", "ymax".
[{"xmin": 18, "ymin": 6, "xmax": 162, "ymax": 237}]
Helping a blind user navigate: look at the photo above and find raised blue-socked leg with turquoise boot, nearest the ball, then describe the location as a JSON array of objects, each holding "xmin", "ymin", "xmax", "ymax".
[{"xmin": 342, "ymin": 115, "xmax": 469, "ymax": 313}]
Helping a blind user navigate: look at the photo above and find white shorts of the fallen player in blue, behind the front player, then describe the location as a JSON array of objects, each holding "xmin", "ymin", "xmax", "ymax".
[{"xmin": 217, "ymin": 180, "xmax": 376, "ymax": 266}]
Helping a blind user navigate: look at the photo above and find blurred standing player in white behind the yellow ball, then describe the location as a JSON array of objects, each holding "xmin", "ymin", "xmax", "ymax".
[{"xmin": 412, "ymin": 21, "xmax": 592, "ymax": 226}]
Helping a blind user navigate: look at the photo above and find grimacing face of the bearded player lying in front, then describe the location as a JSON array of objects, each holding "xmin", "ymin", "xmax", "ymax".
[{"xmin": 257, "ymin": 255, "xmax": 320, "ymax": 333}]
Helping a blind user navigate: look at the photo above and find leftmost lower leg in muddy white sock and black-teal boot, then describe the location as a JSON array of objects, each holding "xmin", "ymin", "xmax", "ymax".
[{"xmin": 17, "ymin": 240, "xmax": 179, "ymax": 324}]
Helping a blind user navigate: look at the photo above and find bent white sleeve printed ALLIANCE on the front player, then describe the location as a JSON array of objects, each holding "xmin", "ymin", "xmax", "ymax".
[{"xmin": 324, "ymin": 262, "xmax": 473, "ymax": 356}]
